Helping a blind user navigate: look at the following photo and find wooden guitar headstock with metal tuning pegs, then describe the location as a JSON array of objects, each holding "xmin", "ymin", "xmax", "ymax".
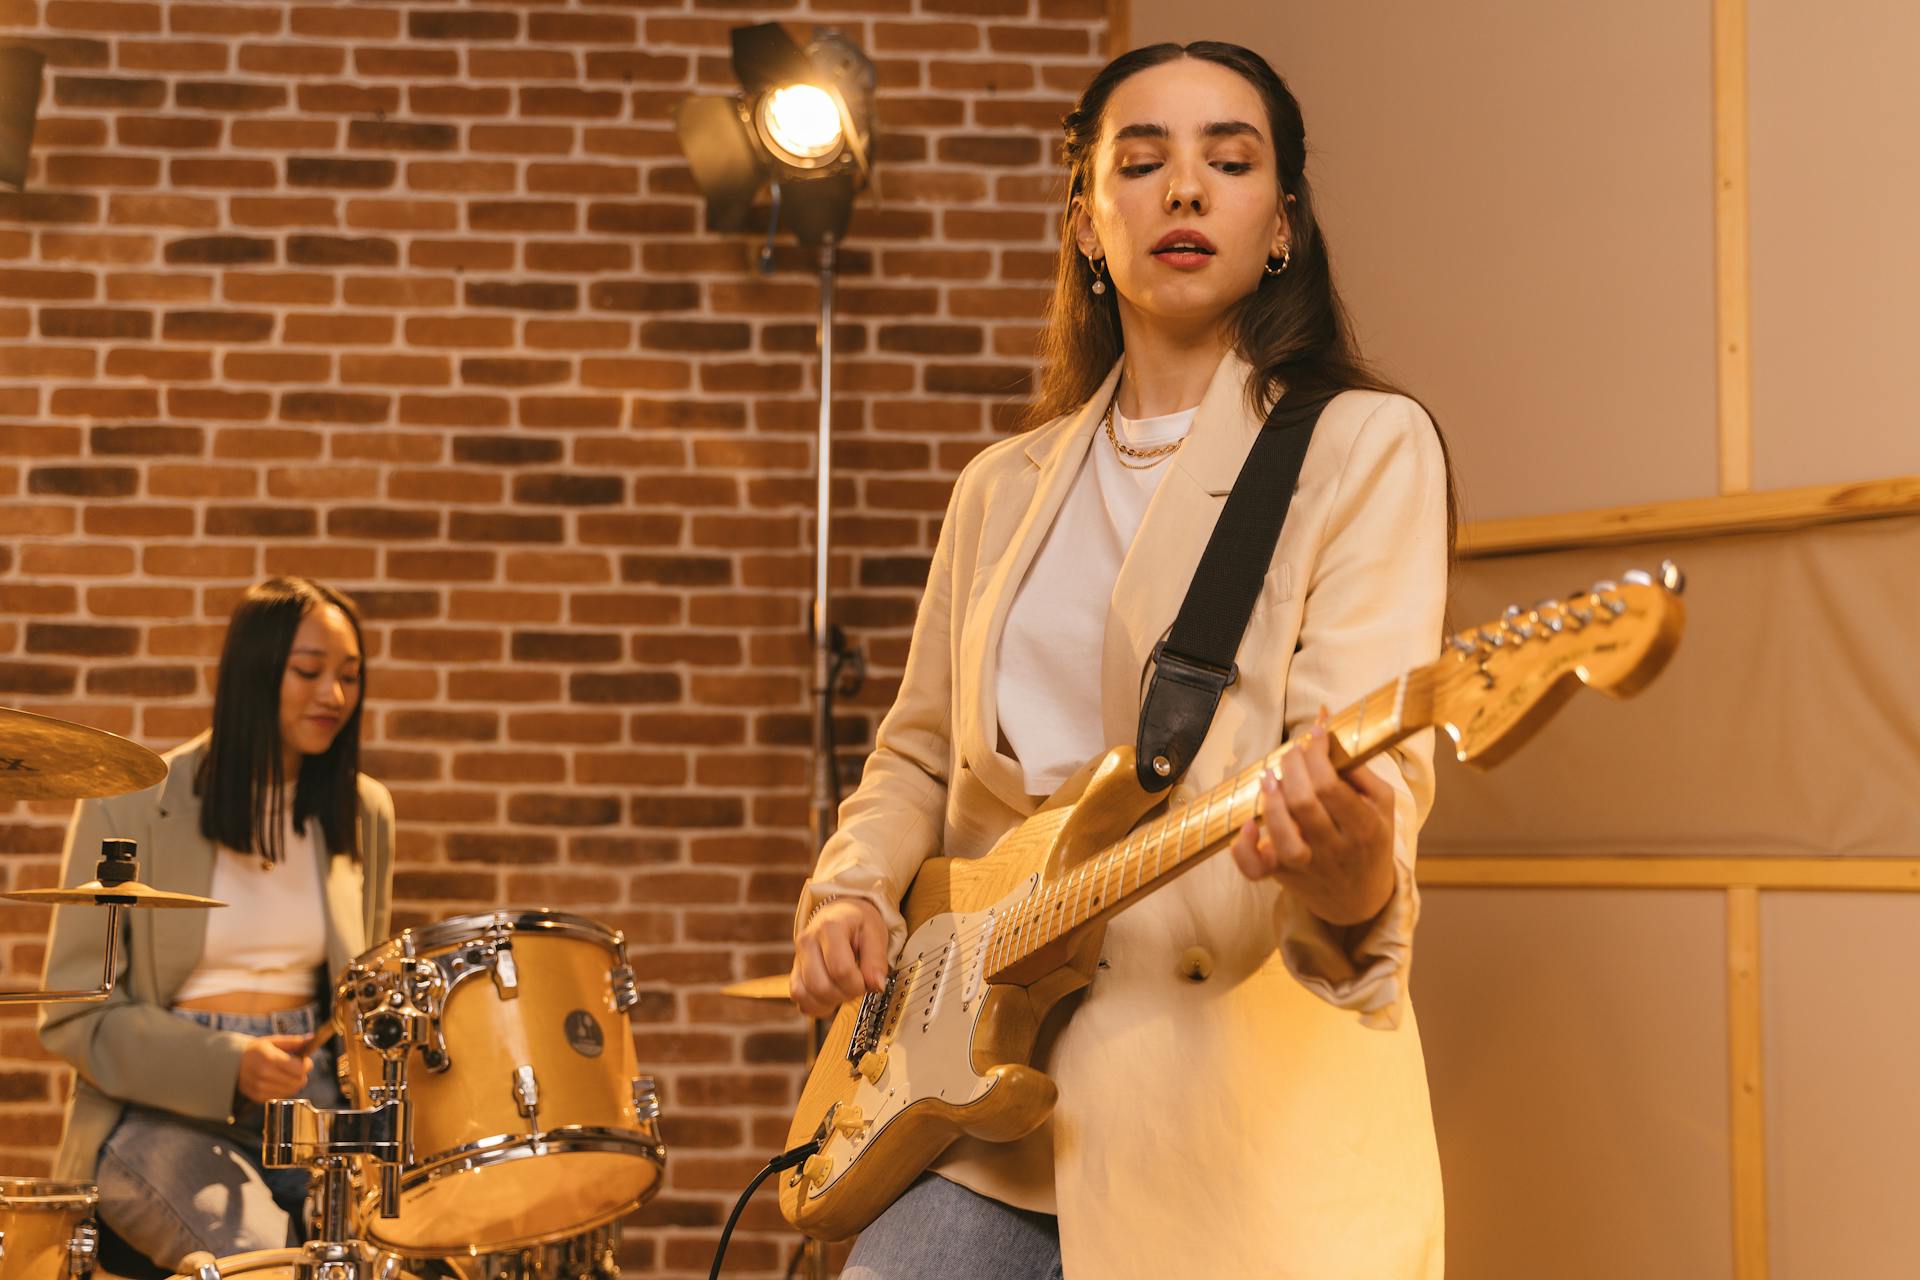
[{"xmin": 1432, "ymin": 560, "xmax": 1686, "ymax": 768}]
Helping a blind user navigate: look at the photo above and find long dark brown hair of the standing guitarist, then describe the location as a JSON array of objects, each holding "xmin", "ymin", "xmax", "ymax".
[{"xmin": 1025, "ymin": 40, "xmax": 1455, "ymax": 549}]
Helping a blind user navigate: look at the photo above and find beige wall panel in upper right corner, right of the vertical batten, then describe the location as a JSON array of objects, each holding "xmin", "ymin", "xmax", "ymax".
[{"xmin": 1749, "ymin": 0, "xmax": 1920, "ymax": 487}]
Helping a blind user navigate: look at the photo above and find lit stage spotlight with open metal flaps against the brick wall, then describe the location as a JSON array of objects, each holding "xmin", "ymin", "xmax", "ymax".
[{"xmin": 674, "ymin": 23, "xmax": 874, "ymax": 251}]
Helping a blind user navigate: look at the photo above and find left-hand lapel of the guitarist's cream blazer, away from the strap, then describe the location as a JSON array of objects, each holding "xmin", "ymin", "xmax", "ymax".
[{"xmin": 956, "ymin": 363, "xmax": 1119, "ymax": 814}]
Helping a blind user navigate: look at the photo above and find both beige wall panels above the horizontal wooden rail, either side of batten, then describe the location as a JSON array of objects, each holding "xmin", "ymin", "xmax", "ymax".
[{"xmin": 1131, "ymin": 0, "xmax": 1920, "ymax": 520}]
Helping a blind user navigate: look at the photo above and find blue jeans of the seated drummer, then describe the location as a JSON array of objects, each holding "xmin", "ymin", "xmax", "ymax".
[{"xmin": 94, "ymin": 1004, "xmax": 346, "ymax": 1270}]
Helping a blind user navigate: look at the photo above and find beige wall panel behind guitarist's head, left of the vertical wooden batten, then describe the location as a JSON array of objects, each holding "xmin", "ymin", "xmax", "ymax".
[{"xmin": 1133, "ymin": 0, "xmax": 1715, "ymax": 520}]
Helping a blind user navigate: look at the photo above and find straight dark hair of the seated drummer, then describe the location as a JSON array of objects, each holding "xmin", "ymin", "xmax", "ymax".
[{"xmin": 194, "ymin": 578, "xmax": 367, "ymax": 862}]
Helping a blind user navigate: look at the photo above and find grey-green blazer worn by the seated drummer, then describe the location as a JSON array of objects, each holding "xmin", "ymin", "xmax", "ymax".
[{"xmin": 40, "ymin": 733, "xmax": 394, "ymax": 1180}]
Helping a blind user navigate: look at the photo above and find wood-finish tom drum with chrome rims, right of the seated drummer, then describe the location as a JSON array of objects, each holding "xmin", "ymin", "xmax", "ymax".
[{"xmin": 334, "ymin": 910, "xmax": 666, "ymax": 1257}]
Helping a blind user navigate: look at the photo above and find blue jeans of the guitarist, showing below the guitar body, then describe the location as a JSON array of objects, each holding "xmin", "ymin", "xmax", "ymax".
[{"xmin": 841, "ymin": 1173, "xmax": 1062, "ymax": 1280}]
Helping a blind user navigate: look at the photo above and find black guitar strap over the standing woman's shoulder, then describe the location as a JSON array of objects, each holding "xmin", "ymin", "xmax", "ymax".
[{"xmin": 1135, "ymin": 391, "xmax": 1338, "ymax": 791}]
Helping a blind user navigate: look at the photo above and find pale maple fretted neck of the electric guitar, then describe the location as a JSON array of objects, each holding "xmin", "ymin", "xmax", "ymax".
[{"xmin": 987, "ymin": 666, "xmax": 1438, "ymax": 981}]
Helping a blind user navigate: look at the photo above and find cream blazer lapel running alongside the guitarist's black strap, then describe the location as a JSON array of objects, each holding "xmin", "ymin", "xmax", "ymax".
[{"xmin": 1100, "ymin": 351, "xmax": 1261, "ymax": 747}]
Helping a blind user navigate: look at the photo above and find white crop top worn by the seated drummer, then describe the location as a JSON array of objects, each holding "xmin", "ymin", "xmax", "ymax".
[{"xmin": 173, "ymin": 804, "xmax": 326, "ymax": 1002}]
